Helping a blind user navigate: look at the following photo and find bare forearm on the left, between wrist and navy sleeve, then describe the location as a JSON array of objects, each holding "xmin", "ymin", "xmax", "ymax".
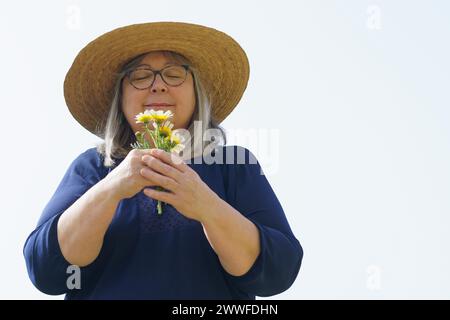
[{"xmin": 58, "ymin": 180, "xmax": 120, "ymax": 266}]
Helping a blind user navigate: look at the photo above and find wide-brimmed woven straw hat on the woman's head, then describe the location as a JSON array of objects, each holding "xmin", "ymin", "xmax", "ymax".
[{"xmin": 64, "ymin": 22, "xmax": 249, "ymax": 138}]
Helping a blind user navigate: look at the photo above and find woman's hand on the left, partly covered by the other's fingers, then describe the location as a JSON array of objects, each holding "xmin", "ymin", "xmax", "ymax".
[{"xmin": 104, "ymin": 149, "xmax": 162, "ymax": 200}]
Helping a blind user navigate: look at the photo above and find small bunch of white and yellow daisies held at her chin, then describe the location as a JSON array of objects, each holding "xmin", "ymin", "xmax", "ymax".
[{"xmin": 131, "ymin": 109, "xmax": 185, "ymax": 215}]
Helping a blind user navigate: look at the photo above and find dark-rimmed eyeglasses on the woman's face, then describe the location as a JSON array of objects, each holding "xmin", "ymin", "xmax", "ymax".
[{"xmin": 126, "ymin": 64, "xmax": 189, "ymax": 90}]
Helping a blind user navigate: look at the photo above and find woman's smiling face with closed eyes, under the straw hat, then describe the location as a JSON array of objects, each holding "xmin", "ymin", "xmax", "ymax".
[{"xmin": 122, "ymin": 51, "xmax": 195, "ymax": 138}]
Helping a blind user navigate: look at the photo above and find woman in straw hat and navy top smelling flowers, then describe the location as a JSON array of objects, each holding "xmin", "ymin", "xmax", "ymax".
[{"xmin": 24, "ymin": 22, "xmax": 303, "ymax": 299}]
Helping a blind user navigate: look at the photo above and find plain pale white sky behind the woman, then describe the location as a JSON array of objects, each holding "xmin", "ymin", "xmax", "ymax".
[{"xmin": 0, "ymin": 0, "xmax": 450, "ymax": 299}]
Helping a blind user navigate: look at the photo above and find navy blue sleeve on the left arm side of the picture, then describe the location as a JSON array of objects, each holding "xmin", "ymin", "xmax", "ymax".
[{"xmin": 23, "ymin": 148, "xmax": 107, "ymax": 295}]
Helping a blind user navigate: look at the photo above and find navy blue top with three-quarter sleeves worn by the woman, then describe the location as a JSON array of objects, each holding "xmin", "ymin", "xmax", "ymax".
[{"xmin": 23, "ymin": 146, "xmax": 303, "ymax": 300}]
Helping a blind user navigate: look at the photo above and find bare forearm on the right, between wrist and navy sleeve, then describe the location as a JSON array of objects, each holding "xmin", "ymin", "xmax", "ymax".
[{"xmin": 201, "ymin": 197, "xmax": 261, "ymax": 276}]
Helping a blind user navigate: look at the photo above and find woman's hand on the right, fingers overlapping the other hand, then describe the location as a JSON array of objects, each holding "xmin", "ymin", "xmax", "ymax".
[{"xmin": 141, "ymin": 149, "xmax": 219, "ymax": 222}]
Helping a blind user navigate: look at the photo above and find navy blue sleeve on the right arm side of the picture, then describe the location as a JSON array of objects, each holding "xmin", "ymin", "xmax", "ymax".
[{"xmin": 223, "ymin": 146, "xmax": 303, "ymax": 297}]
